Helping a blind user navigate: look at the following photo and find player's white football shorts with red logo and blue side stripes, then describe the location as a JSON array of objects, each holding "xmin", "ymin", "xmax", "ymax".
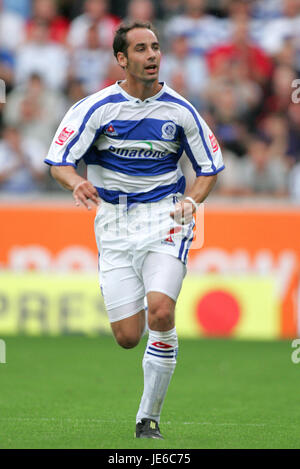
[{"xmin": 95, "ymin": 196, "xmax": 194, "ymax": 322}]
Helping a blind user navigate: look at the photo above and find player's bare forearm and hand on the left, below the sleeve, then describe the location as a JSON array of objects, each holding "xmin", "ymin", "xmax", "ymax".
[{"xmin": 50, "ymin": 166, "xmax": 100, "ymax": 210}]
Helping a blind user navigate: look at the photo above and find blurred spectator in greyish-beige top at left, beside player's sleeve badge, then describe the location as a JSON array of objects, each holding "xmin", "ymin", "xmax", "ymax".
[{"xmin": 3, "ymin": 74, "xmax": 66, "ymax": 146}]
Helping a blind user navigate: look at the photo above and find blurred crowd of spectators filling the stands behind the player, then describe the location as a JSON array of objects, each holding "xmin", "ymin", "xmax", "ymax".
[{"xmin": 0, "ymin": 0, "xmax": 300, "ymax": 203}]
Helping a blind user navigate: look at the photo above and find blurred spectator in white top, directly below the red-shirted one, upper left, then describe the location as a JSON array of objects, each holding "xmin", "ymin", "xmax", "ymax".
[{"xmin": 15, "ymin": 20, "xmax": 69, "ymax": 89}]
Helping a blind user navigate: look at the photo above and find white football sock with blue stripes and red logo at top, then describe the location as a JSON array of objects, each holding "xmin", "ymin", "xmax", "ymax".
[{"xmin": 136, "ymin": 327, "xmax": 178, "ymax": 422}]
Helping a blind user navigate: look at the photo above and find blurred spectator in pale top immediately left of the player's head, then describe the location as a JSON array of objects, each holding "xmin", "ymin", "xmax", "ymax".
[{"xmin": 70, "ymin": 25, "xmax": 112, "ymax": 94}]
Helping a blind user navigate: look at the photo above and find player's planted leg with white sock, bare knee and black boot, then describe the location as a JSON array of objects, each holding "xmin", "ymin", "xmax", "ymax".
[{"xmin": 136, "ymin": 252, "xmax": 186, "ymax": 438}]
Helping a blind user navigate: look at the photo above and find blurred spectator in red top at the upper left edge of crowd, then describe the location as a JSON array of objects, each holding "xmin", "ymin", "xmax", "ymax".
[{"xmin": 26, "ymin": 0, "xmax": 69, "ymax": 44}]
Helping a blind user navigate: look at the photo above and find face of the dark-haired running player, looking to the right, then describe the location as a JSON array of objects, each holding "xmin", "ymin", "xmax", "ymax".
[{"xmin": 119, "ymin": 28, "xmax": 161, "ymax": 83}]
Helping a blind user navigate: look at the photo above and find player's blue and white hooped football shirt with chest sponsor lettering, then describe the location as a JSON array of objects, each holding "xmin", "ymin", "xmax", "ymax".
[{"xmin": 45, "ymin": 83, "xmax": 224, "ymax": 204}]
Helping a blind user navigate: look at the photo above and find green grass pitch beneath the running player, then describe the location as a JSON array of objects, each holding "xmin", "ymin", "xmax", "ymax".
[{"xmin": 0, "ymin": 336, "xmax": 300, "ymax": 449}]
